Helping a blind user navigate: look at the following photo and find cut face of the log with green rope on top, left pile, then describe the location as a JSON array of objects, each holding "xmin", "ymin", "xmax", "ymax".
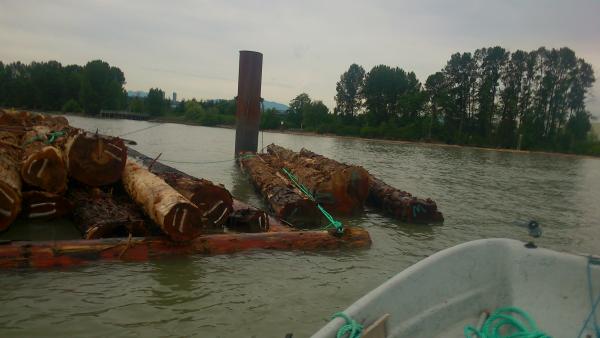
[{"xmin": 21, "ymin": 147, "xmax": 67, "ymax": 193}]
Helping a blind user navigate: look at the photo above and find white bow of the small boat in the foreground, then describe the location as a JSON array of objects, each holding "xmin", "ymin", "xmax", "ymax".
[{"xmin": 313, "ymin": 239, "xmax": 600, "ymax": 338}]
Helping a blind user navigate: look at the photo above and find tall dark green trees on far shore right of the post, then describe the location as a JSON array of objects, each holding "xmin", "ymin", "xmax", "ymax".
[{"xmin": 276, "ymin": 47, "xmax": 600, "ymax": 155}]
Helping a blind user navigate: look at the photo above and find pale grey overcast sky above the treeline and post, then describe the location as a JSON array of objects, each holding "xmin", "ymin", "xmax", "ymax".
[{"xmin": 0, "ymin": 0, "xmax": 600, "ymax": 116}]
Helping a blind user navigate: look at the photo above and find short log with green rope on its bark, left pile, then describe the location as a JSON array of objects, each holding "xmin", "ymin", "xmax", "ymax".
[{"xmin": 21, "ymin": 126, "xmax": 67, "ymax": 194}]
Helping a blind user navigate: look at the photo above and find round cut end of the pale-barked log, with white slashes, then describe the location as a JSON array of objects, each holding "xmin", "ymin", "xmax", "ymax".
[{"xmin": 163, "ymin": 203, "xmax": 202, "ymax": 241}]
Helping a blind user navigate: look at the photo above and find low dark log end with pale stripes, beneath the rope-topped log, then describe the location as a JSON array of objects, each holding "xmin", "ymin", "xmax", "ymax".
[{"xmin": 22, "ymin": 191, "xmax": 72, "ymax": 219}]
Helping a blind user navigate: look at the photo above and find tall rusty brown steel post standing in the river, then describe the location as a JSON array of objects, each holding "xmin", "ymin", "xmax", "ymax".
[{"xmin": 235, "ymin": 50, "xmax": 262, "ymax": 156}]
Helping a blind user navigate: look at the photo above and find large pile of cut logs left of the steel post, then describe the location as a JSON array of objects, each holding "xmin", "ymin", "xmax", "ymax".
[{"xmin": 0, "ymin": 109, "xmax": 268, "ymax": 241}]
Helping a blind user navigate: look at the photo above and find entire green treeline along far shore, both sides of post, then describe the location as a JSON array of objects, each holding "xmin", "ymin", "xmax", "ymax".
[{"xmin": 0, "ymin": 47, "xmax": 600, "ymax": 156}]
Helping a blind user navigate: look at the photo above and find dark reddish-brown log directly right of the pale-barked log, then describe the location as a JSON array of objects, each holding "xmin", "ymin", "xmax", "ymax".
[{"xmin": 159, "ymin": 173, "xmax": 233, "ymax": 232}]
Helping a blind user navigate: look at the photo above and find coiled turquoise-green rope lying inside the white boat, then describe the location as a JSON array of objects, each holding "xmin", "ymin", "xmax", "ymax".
[{"xmin": 464, "ymin": 307, "xmax": 551, "ymax": 338}]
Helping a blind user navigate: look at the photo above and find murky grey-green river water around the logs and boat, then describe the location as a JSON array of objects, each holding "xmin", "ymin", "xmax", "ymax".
[{"xmin": 0, "ymin": 116, "xmax": 600, "ymax": 337}]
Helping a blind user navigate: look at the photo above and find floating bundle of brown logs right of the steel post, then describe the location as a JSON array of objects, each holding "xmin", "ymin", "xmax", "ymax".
[{"xmin": 239, "ymin": 144, "xmax": 443, "ymax": 227}]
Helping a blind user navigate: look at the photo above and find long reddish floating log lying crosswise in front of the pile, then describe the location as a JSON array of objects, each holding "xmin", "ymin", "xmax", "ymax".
[{"xmin": 0, "ymin": 227, "xmax": 371, "ymax": 268}]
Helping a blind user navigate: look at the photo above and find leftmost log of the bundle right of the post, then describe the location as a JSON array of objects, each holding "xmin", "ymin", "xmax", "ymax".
[{"xmin": 240, "ymin": 155, "xmax": 321, "ymax": 227}]
